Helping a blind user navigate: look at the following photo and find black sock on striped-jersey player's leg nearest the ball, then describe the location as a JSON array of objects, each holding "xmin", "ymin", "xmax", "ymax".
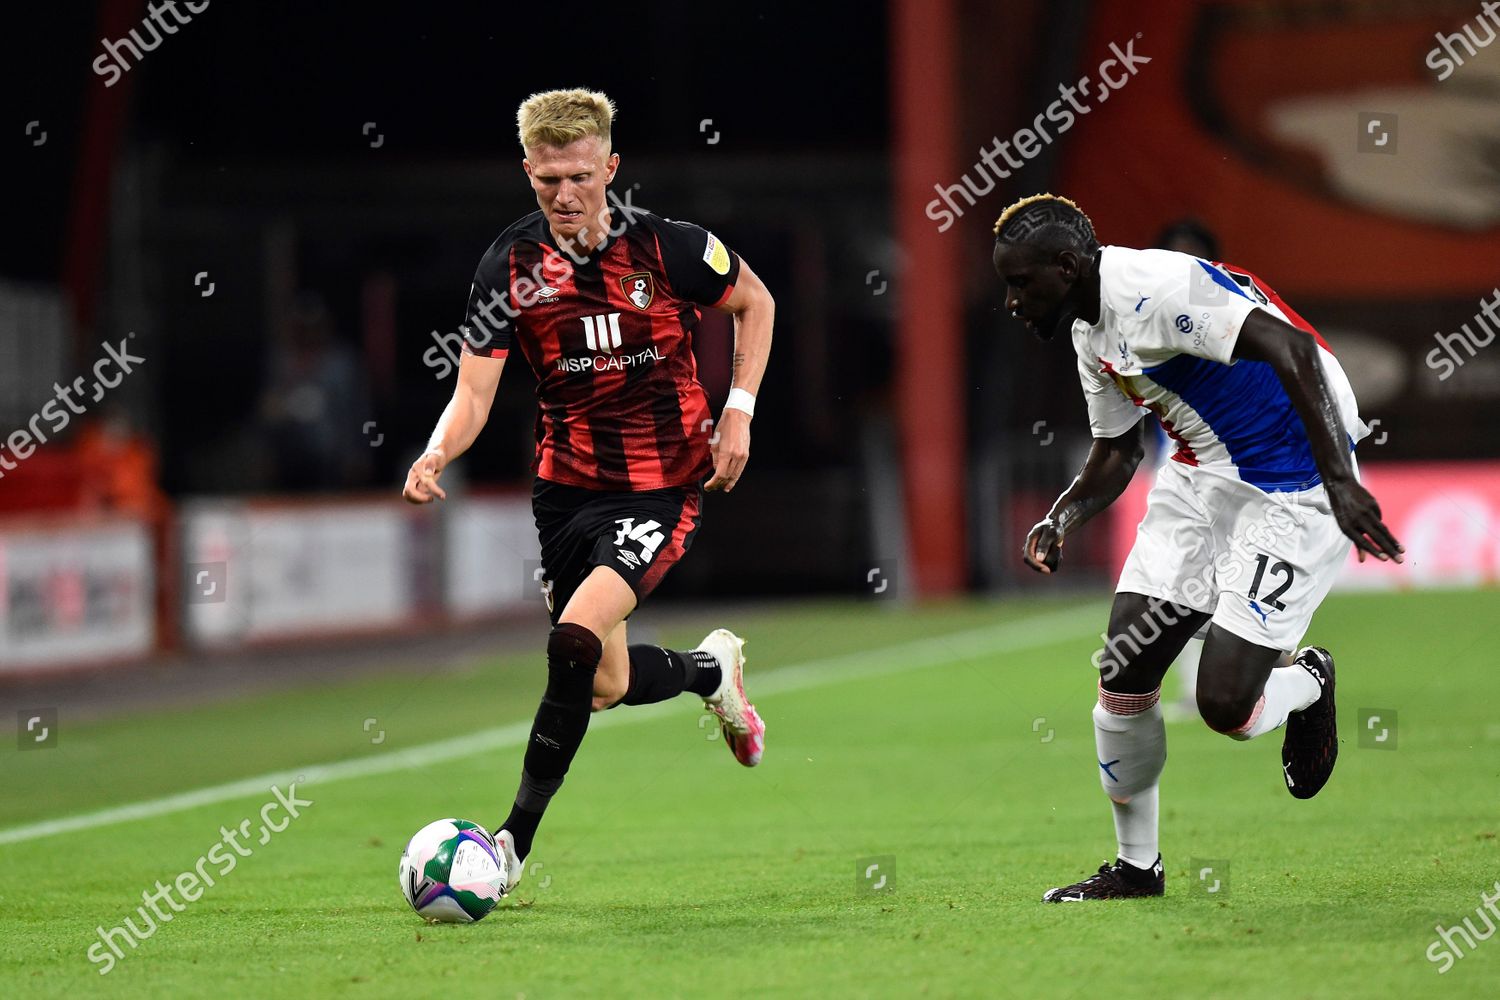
[{"xmin": 503, "ymin": 622, "xmax": 603, "ymax": 858}]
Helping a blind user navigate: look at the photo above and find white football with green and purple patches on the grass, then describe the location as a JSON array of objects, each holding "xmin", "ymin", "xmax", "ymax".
[{"xmin": 398, "ymin": 819, "xmax": 506, "ymax": 924}]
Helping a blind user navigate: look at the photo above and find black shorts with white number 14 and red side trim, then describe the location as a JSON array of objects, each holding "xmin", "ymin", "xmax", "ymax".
[{"xmin": 531, "ymin": 478, "xmax": 704, "ymax": 625}]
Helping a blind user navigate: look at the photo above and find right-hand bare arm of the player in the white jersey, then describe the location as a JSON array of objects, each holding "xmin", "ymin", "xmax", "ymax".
[{"xmin": 1235, "ymin": 309, "xmax": 1406, "ymax": 562}]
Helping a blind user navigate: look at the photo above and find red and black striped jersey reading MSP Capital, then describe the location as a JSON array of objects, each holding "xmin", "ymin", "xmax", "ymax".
[{"xmin": 462, "ymin": 210, "xmax": 740, "ymax": 490}]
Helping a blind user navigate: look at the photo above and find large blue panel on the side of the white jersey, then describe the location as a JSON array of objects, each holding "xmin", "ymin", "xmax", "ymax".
[{"xmin": 1145, "ymin": 354, "xmax": 1322, "ymax": 493}]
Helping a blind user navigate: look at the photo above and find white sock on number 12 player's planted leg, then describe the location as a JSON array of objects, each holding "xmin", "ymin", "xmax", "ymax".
[{"xmin": 1094, "ymin": 688, "xmax": 1167, "ymax": 868}]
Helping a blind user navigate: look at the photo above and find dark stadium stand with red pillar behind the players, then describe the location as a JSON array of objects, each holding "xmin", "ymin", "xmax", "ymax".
[{"xmin": 0, "ymin": 0, "xmax": 1500, "ymax": 669}]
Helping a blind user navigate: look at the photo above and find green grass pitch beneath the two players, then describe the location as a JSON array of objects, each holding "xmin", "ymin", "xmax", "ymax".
[{"xmin": 0, "ymin": 591, "xmax": 1500, "ymax": 999}]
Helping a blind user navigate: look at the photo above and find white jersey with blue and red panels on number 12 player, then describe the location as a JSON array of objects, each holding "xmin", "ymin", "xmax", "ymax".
[{"xmin": 1073, "ymin": 246, "xmax": 1370, "ymax": 493}]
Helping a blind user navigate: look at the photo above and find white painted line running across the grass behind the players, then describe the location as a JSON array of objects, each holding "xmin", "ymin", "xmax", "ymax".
[{"xmin": 0, "ymin": 606, "xmax": 1103, "ymax": 844}]
